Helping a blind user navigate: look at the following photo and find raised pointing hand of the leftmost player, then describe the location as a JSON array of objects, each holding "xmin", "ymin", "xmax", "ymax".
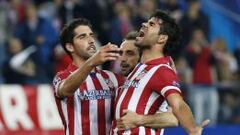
[{"xmin": 89, "ymin": 43, "xmax": 120, "ymax": 66}]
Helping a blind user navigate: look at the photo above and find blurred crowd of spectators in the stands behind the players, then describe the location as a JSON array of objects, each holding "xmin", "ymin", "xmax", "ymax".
[{"xmin": 0, "ymin": 0, "xmax": 240, "ymax": 124}]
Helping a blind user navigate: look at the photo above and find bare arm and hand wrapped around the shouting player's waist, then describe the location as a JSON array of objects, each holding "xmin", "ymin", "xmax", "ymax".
[{"xmin": 117, "ymin": 110, "xmax": 178, "ymax": 130}]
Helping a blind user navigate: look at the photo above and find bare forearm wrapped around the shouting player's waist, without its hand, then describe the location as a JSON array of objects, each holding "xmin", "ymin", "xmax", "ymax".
[{"xmin": 140, "ymin": 112, "xmax": 178, "ymax": 128}]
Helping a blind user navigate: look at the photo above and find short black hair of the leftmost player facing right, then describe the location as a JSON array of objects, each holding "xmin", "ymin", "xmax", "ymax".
[{"xmin": 59, "ymin": 18, "xmax": 92, "ymax": 57}]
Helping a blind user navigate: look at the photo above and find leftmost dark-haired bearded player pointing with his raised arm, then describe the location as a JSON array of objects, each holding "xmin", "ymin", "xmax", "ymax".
[{"xmin": 53, "ymin": 19, "xmax": 124, "ymax": 135}]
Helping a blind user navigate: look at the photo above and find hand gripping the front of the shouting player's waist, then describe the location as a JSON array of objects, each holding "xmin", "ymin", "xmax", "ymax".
[{"xmin": 117, "ymin": 110, "xmax": 141, "ymax": 130}]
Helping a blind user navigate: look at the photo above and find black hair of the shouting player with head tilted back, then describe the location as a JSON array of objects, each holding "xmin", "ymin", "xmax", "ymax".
[{"xmin": 150, "ymin": 10, "xmax": 180, "ymax": 56}]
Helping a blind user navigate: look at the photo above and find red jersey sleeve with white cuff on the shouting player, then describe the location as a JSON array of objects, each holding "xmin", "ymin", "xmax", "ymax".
[{"xmin": 152, "ymin": 66, "xmax": 181, "ymax": 98}]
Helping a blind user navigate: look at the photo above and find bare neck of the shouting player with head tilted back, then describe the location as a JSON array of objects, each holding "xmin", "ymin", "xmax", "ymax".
[{"xmin": 141, "ymin": 48, "xmax": 164, "ymax": 63}]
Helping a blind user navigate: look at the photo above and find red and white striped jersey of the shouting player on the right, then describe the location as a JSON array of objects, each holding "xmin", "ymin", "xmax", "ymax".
[{"xmin": 111, "ymin": 57, "xmax": 181, "ymax": 135}]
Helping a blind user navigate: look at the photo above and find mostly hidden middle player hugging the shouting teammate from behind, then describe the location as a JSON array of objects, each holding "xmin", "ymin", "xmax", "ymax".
[{"xmin": 115, "ymin": 32, "xmax": 178, "ymax": 130}]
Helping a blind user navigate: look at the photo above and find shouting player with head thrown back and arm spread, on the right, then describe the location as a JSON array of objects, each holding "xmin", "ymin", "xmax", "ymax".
[{"xmin": 112, "ymin": 11, "xmax": 209, "ymax": 135}]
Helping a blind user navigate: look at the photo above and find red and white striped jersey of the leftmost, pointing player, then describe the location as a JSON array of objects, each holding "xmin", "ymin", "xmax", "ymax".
[{"xmin": 53, "ymin": 65, "xmax": 124, "ymax": 135}]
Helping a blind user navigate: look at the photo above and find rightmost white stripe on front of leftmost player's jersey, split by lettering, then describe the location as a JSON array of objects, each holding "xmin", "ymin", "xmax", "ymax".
[{"xmin": 97, "ymin": 74, "xmax": 112, "ymax": 133}]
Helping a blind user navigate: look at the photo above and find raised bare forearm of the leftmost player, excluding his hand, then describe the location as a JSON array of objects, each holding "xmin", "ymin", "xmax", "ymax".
[{"xmin": 58, "ymin": 60, "xmax": 95, "ymax": 97}]
